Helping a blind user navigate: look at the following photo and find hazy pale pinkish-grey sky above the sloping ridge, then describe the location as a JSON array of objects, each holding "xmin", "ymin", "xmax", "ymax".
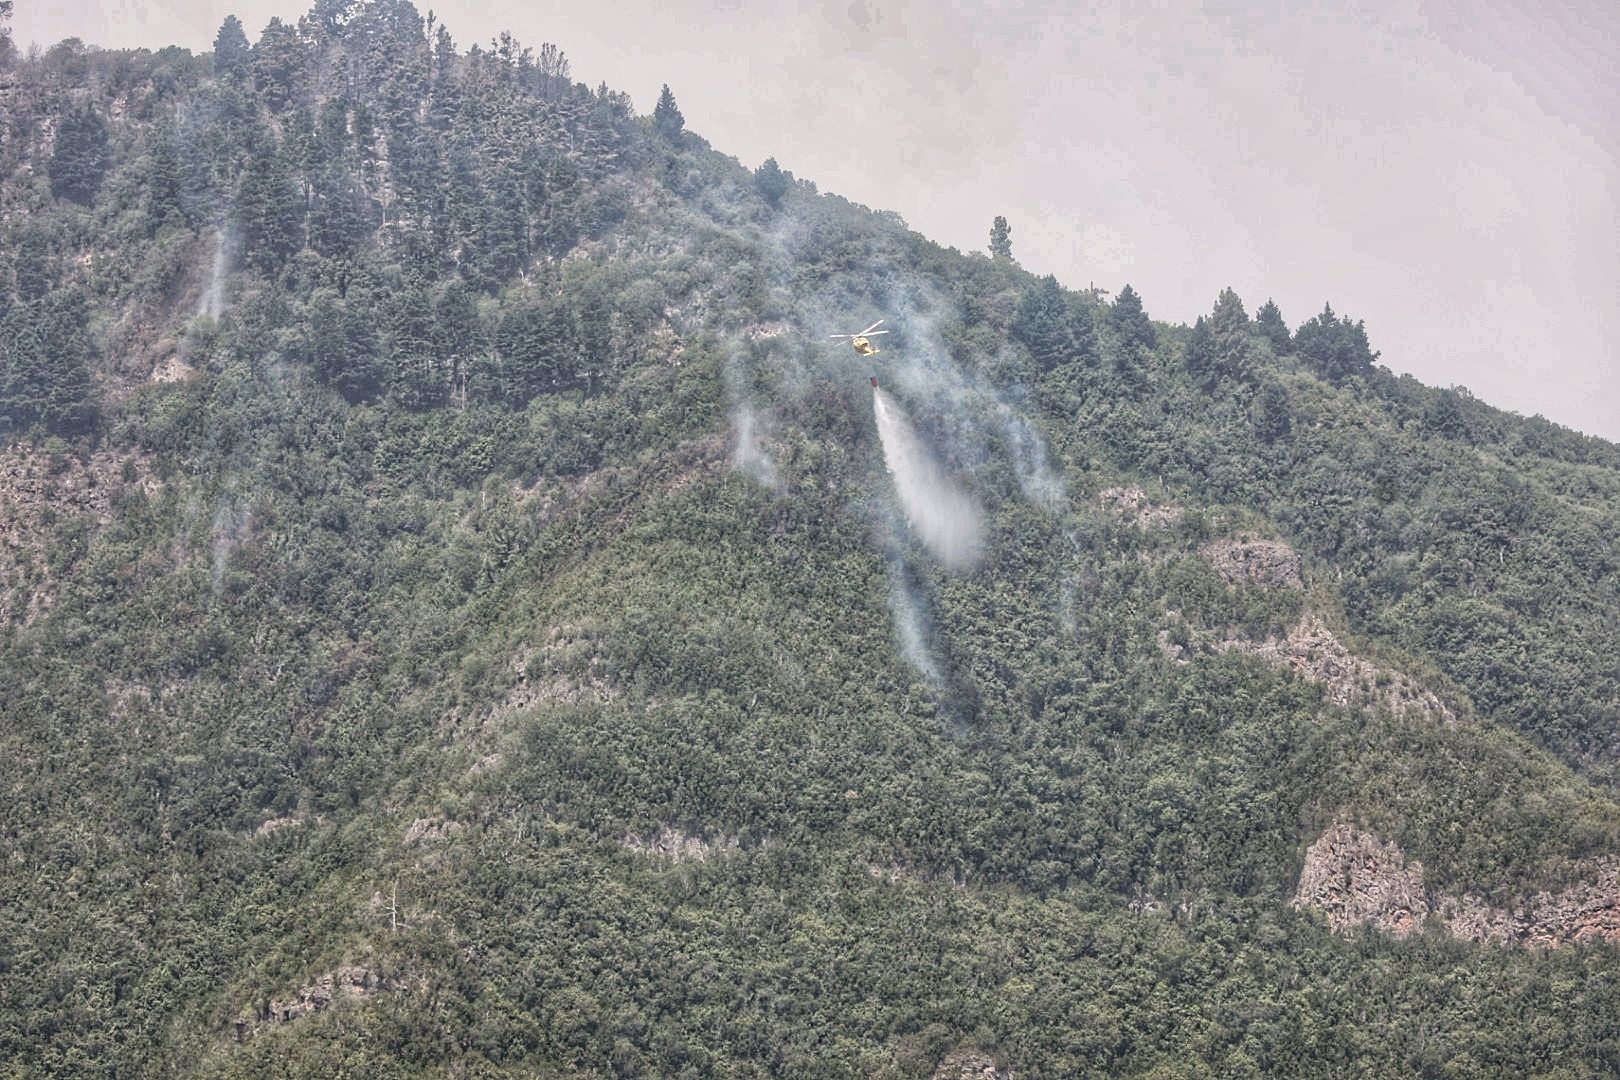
[{"xmin": 15, "ymin": 0, "xmax": 1620, "ymax": 439}]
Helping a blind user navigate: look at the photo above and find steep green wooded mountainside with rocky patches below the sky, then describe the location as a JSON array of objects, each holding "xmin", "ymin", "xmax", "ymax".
[{"xmin": 0, "ymin": 0, "xmax": 1620, "ymax": 1077}]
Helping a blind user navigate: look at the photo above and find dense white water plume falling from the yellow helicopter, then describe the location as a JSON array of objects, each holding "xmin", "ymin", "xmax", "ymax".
[{"xmin": 872, "ymin": 389, "xmax": 985, "ymax": 570}]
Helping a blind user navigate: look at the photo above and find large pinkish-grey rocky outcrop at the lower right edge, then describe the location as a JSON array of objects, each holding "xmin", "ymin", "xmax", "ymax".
[{"xmin": 1293, "ymin": 821, "xmax": 1620, "ymax": 949}]
